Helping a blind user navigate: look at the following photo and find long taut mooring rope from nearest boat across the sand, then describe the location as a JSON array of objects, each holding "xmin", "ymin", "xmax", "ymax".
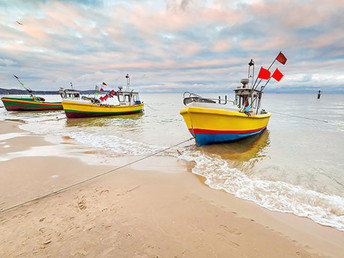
[{"xmin": 0, "ymin": 137, "xmax": 193, "ymax": 214}]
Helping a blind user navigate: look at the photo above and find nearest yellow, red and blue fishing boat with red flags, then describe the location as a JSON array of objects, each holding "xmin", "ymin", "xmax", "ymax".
[{"xmin": 180, "ymin": 52, "xmax": 286, "ymax": 146}]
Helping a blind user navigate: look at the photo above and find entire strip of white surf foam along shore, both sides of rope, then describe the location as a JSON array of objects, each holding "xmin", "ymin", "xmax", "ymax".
[{"xmin": 65, "ymin": 132, "xmax": 344, "ymax": 231}]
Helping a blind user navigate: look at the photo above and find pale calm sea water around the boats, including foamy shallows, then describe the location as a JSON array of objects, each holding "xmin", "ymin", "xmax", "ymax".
[{"xmin": 0, "ymin": 94, "xmax": 344, "ymax": 231}]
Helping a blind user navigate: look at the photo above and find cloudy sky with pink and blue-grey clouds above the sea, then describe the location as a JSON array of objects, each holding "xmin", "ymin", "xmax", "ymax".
[{"xmin": 0, "ymin": 0, "xmax": 344, "ymax": 93}]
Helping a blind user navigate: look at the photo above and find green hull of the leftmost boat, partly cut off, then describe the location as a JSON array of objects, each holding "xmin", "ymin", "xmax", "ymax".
[{"xmin": 1, "ymin": 97, "xmax": 62, "ymax": 111}]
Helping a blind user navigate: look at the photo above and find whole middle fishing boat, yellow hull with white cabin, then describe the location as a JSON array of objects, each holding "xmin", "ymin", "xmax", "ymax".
[{"xmin": 62, "ymin": 75, "xmax": 143, "ymax": 118}]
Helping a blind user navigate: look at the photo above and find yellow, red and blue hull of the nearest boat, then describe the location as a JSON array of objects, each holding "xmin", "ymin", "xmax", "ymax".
[{"xmin": 180, "ymin": 107, "xmax": 271, "ymax": 146}]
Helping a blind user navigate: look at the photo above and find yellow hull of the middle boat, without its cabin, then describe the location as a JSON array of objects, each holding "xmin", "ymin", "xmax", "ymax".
[{"xmin": 62, "ymin": 101, "xmax": 143, "ymax": 118}]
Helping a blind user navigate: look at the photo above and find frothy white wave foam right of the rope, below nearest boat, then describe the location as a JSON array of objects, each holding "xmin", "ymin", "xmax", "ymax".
[{"xmin": 180, "ymin": 151, "xmax": 344, "ymax": 231}]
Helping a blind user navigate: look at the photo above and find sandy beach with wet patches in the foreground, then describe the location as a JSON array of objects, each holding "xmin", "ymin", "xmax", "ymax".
[{"xmin": 0, "ymin": 121, "xmax": 344, "ymax": 257}]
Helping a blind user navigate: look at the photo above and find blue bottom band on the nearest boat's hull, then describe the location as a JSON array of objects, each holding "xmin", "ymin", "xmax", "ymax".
[{"xmin": 191, "ymin": 128, "xmax": 265, "ymax": 146}]
